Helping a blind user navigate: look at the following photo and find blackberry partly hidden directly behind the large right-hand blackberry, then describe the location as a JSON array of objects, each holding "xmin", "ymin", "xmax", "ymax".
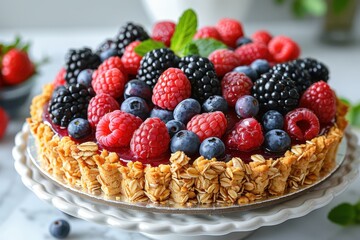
[{"xmin": 270, "ymin": 62, "xmax": 311, "ymax": 95}]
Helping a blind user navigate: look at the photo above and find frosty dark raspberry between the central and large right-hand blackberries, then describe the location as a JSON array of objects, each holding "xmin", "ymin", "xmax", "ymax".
[{"xmin": 221, "ymin": 72, "xmax": 253, "ymax": 107}]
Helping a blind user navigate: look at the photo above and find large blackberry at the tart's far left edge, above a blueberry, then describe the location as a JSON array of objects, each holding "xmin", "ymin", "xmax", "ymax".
[{"xmin": 48, "ymin": 83, "xmax": 95, "ymax": 127}]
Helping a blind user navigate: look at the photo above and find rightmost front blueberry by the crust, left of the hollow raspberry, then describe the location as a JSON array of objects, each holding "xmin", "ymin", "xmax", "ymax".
[{"xmin": 264, "ymin": 129, "xmax": 291, "ymax": 153}]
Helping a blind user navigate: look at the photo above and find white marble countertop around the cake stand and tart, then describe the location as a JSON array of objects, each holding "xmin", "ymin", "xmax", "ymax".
[{"xmin": 0, "ymin": 23, "xmax": 360, "ymax": 240}]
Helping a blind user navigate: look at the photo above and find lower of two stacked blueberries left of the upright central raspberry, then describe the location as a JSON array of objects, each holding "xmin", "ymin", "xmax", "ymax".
[{"xmin": 120, "ymin": 97, "xmax": 150, "ymax": 120}]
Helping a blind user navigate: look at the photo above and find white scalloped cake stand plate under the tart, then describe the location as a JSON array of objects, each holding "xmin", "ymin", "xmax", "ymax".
[{"xmin": 12, "ymin": 124, "xmax": 359, "ymax": 240}]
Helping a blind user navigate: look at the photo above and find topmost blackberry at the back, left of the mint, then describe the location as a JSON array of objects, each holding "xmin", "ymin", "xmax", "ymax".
[{"xmin": 114, "ymin": 22, "xmax": 149, "ymax": 57}]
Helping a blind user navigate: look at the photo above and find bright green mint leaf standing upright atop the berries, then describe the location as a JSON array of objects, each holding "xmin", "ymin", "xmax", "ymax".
[{"xmin": 170, "ymin": 9, "xmax": 197, "ymax": 53}]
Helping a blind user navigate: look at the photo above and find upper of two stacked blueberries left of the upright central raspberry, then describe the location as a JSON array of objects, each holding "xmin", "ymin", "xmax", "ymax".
[{"xmin": 124, "ymin": 79, "xmax": 152, "ymax": 102}]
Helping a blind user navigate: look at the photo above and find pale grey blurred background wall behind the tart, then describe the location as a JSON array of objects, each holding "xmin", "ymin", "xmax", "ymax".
[{"xmin": 0, "ymin": 0, "xmax": 292, "ymax": 30}]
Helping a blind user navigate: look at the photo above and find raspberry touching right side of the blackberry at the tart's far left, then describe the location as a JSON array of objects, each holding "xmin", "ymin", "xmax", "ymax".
[{"xmin": 88, "ymin": 93, "xmax": 120, "ymax": 127}]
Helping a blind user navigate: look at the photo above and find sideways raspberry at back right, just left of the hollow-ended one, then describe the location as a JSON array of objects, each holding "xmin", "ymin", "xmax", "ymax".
[{"xmin": 235, "ymin": 43, "xmax": 271, "ymax": 65}]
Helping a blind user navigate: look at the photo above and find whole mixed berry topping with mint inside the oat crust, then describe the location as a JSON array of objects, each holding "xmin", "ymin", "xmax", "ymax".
[{"xmin": 43, "ymin": 10, "xmax": 337, "ymax": 166}]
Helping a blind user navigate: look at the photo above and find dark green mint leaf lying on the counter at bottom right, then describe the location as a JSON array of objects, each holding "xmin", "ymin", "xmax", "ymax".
[{"xmin": 328, "ymin": 203, "xmax": 356, "ymax": 226}]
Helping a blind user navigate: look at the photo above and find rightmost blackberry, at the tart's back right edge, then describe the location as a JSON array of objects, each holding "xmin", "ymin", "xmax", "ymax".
[{"xmin": 294, "ymin": 58, "xmax": 329, "ymax": 83}]
